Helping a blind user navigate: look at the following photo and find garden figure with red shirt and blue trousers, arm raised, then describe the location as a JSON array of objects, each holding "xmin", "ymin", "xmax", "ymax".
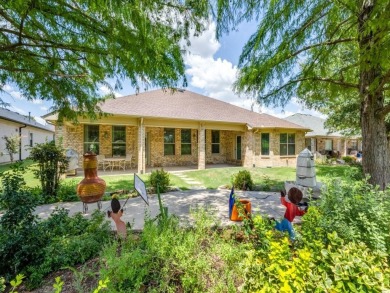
[{"xmin": 275, "ymin": 187, "xmax": 308, "ymax": 240}]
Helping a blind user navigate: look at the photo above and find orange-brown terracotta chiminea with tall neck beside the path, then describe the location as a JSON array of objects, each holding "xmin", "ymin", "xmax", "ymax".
[{"xmin": 77, "ymin": 153, "xmax": 106, "ymax": 203}]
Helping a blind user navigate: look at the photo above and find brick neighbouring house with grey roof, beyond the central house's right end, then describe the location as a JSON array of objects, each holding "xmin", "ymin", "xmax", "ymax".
[{"xmin": 284, "ymin": 113, "xmax": 362, "ymax": 156}]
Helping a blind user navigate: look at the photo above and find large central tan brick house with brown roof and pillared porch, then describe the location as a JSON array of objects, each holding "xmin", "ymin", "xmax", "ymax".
[{"xmin": 44, "ymin": 90, "xmax": 309, "ymax": 173}]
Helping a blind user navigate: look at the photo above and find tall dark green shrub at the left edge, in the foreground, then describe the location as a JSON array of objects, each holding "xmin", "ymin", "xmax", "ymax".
[{"xmin": 0, "ymin": 164, "xmax": 47, "ymax": 280}]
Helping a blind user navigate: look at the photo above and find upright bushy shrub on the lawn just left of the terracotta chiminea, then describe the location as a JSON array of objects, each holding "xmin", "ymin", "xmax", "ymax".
[{"xmin": 29, "ymin": 141, "xmax": 68, "ymax": 198}]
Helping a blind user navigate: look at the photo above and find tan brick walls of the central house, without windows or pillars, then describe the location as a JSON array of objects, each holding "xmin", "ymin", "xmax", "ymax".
[{"xmin": 56, "ymin": 124, "xmax": 305, "ymax": 167}]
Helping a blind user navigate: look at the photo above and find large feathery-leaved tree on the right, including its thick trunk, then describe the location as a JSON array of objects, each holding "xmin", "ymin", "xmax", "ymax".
[{"xmin": 216, "ymin": 0, "xmax": 390, "ymax": 189}]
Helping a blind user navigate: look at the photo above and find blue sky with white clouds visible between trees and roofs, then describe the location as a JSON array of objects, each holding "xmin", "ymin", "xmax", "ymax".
[{"xmin": 0, "ymin": 22, "xmax": 324, "ymax": 124}]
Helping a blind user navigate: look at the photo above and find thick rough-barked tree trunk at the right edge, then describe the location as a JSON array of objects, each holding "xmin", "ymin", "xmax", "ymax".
[{"xmin": 359, "ymin": 0, "xmax": 390, "ymax": 189}]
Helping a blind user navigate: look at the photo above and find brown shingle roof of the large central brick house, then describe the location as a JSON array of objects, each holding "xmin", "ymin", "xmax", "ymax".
[{"xmin": 101, "ymin": 90, "xmax": 307, "ymax": 129}]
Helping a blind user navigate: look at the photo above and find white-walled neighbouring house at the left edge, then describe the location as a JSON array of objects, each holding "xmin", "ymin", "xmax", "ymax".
[{"xmin": 0, "ymin": 108, "xmax": 54, "ymax": 163}]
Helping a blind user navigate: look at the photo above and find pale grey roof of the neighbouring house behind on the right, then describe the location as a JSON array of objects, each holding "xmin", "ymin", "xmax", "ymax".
[{"xmin": 284, "ymin": 113, "xmax": 343, "ymax": 137}]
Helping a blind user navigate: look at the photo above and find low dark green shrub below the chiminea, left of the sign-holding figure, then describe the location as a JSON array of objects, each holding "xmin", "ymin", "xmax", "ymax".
[{"xmin": 26, "ymin": 209, "xmax": 110, "ymax": 288}]
